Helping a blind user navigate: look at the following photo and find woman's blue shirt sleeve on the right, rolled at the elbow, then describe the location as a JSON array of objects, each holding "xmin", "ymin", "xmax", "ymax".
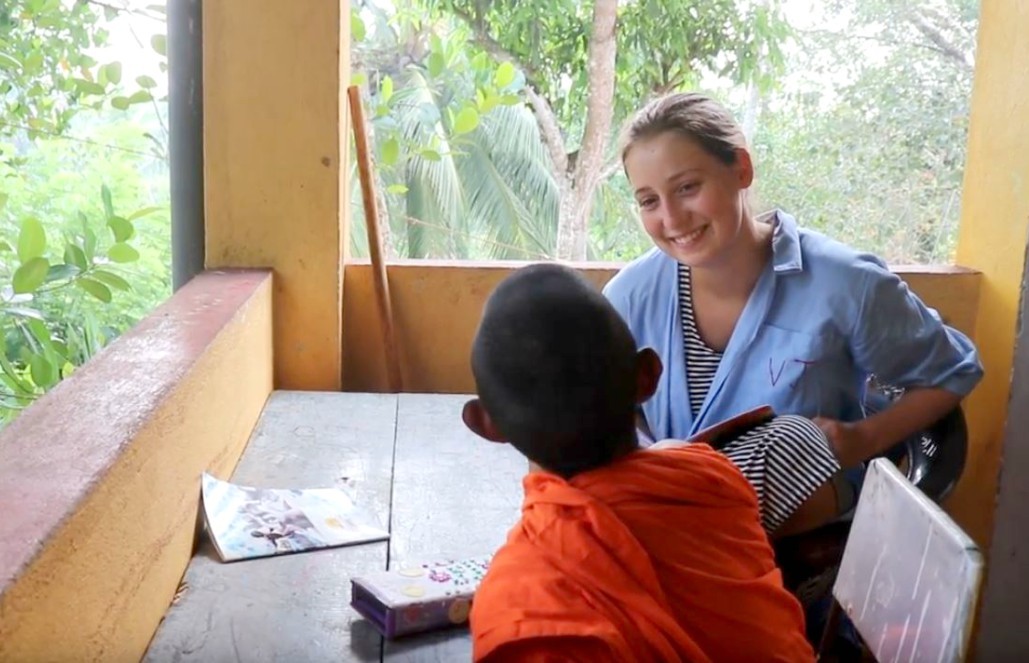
[{"xmin": 851, "ymin": 260, "xmax": 983, "ymax": 396}]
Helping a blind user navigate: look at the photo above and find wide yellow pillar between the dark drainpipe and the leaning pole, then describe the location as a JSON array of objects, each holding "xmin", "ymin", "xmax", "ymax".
[{"xmin": 204, "ymin": 0, "xmax": 350, "ymax": 390}]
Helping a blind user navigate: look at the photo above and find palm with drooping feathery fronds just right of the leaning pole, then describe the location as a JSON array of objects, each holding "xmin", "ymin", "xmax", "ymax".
[{"xmin": 351, "ymin": 53, "xmax": 558, "ymax": 259}]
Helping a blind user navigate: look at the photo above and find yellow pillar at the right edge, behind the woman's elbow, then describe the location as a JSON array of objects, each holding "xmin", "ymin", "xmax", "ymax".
[{"xmin": 950, "ymin": 0, "xmax": 1029, "ymax": 545}]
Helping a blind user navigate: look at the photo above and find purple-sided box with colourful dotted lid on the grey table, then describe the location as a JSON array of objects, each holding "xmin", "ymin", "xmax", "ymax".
[{"xmin": 350, "ymin": 555, "xmax": 492, "ymax": 638}]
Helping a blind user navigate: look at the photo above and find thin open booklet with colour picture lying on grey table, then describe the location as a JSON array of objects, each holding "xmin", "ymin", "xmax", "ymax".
[{"xmin": 202, "ymin": 473, "xmax": 389, "ymax": 562}]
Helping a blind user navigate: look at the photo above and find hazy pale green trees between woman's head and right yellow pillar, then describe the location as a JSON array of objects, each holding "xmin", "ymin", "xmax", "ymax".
[{"xmin": 755, "ymin": 0, "xmax": 978, "ymax": 263}]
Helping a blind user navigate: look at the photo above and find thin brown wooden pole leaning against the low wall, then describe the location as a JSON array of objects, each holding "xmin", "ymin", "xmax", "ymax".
[{"xmin": 347, "ymin": 85, "xmax": 403, "ymax": 393}]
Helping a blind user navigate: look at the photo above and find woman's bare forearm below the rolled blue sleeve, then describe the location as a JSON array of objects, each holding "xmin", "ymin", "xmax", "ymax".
[{"xmin": 814, "ymin": 388, "xmax": 961, "ymax": 467}]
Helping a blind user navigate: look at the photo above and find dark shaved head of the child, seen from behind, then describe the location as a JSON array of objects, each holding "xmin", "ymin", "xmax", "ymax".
[{"xmin": 471, "ymin": 264, "xmax": 638, "ymax": 477}]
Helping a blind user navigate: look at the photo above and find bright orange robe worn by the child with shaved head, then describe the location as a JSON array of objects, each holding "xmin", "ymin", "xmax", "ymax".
[{"xmin": 470, "ymin": 444, "xmax": 814, "ymax": 663}]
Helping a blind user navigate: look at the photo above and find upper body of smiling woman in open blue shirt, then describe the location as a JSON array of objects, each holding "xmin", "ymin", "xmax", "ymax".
[{"xmin": 605, "ymin": 94, "xmax": 982, "ymax": 508}]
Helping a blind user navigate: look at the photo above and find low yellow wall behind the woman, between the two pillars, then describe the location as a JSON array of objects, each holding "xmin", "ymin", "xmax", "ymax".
[{"xmin": 344, "ymin": 260, "xmax": 980, "ymax": 393}]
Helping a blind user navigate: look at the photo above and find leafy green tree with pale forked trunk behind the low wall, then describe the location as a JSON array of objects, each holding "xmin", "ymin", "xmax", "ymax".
[{"xmin": 355, "ymin": 0, "xmax": 787, "ymax": 259}]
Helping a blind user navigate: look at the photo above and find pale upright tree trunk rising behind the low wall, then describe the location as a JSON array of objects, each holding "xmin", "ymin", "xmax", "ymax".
[{"xmin": 552, "ymin": 0, "xmax": 618, "ymax": 260}]
